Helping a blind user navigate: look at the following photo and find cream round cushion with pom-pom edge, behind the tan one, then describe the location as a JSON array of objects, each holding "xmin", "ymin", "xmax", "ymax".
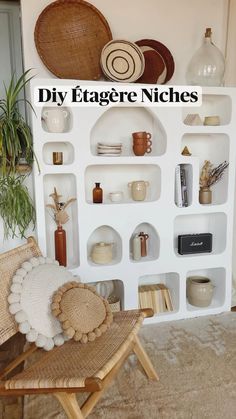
[{"xmin": 8, "ymin": 257, "xmax": 79, "ymax": 351}]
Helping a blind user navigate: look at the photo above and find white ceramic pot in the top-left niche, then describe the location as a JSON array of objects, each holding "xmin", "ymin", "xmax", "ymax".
[{"xmin": 42, "ymin": 109, "xmax": 69, "ymax": 133}]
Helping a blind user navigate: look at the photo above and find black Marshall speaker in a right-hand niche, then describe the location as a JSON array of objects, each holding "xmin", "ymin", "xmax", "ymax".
[{"xmin": 178, "ymin": 233, "xmax": 212, "ymax": 255}]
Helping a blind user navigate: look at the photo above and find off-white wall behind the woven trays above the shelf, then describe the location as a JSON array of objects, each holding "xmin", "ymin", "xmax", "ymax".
[{"xmin": 21, "ymin": 0, "xmax": 228, "ymax": 84}]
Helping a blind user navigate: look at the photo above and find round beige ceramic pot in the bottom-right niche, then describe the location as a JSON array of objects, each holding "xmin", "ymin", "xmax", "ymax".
[{"xmin": 187, "ymin": 276, "xmax": 214, "ymax": 307}]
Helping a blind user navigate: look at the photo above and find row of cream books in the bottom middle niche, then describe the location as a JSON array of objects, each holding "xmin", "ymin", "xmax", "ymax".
[{"xmin": 138, "ymin": 284, "xmax": 173, "ymax": 313}]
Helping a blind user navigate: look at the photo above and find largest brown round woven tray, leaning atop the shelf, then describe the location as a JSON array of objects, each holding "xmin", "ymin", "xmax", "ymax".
[{"xmin": 34, "ymin": 0, "xmax": 112, "ymax": 80}]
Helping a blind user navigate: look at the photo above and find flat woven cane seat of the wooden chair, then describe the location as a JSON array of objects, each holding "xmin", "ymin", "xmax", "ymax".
[{"xmin": 5, "ymin": 310, "xmax": 144, "ymax": 389}]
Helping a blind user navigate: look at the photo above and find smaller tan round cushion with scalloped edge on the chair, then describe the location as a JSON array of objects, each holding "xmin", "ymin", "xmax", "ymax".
[{"xmin": 51, "ymin": 282, "xmax": 113, "ymax": 343}]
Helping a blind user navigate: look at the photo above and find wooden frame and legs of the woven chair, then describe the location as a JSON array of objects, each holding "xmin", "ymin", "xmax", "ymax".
[{"xmin": 0, "ymin": 237, "xmax": 158, "ymax": 419}]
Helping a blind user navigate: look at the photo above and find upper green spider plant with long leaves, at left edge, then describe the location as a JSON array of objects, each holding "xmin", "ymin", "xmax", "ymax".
[{"xmin": 0, "ymin": 70, "xmax": 38, "ymax": 176}]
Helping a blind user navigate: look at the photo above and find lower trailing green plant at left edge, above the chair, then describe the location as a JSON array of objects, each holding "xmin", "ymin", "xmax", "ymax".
[{"xmin": 0, "ymin": 175, "xmax": 36, "ymax": 239}]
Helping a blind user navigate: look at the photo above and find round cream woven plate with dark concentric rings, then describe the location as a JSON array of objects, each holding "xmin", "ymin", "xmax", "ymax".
[{"xmin": 101, "ymin": 40, "xmax": 145, "ymax": 83}]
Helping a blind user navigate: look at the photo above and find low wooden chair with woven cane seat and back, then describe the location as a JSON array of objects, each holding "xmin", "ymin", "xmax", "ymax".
[{"xmin": 0, "ymin": 237, "xmax": 158, "ymax": 419}]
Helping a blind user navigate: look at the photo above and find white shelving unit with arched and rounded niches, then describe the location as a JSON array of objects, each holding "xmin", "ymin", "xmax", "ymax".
[{"xmin": 32, "ymin": 79, "xmax": 236, "ymax": 322}]
